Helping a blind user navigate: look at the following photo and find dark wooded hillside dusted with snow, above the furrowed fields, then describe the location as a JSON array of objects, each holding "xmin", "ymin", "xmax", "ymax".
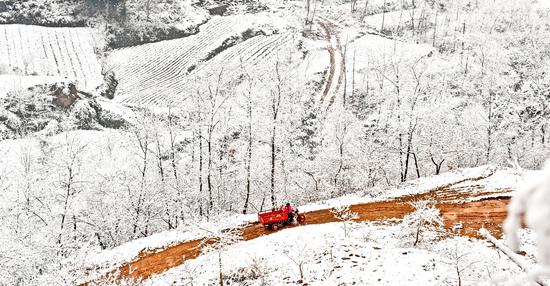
[{"xmin": 0, "ymin": 0, "xmax": 208, "ymax": 48}]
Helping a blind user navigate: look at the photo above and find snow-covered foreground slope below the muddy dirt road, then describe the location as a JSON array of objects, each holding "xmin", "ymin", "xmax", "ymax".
[{"xmin": 143, "ymin": 223, "xmax": 536, "ymax": 285}]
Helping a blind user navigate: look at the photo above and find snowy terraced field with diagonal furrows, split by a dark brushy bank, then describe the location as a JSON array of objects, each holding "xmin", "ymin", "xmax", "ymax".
[{"xmin": 109, "ymin": 16, "xmax": 298, "ymax": 106}]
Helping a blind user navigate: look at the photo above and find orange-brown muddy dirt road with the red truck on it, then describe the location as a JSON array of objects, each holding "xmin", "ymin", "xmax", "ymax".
[{"xmin": 86, "ymin": 172, "xmax": 510, "ymax": 285}]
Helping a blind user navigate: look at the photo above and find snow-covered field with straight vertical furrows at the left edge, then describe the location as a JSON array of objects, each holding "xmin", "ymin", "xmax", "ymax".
[{"xmin": 0, "ymin": 24, "xmax": 102, "ymax": 90}]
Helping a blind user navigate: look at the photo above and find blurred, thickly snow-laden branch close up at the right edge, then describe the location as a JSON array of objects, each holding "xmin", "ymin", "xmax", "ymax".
[{"xmin": 504, "ymin": 160, "xmax": 550, "ymax": 278}]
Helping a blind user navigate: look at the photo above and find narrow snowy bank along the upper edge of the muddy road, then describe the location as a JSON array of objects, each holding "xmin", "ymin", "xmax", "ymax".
[{"xmin": 86, "ymin": 165, "xmax": 535, "ymax": 275}]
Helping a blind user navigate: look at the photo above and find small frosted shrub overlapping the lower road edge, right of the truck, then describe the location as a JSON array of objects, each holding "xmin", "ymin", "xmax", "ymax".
[{"xmin": 399, "ymin": 201, "xmax": 443, "ymax": 247}]
